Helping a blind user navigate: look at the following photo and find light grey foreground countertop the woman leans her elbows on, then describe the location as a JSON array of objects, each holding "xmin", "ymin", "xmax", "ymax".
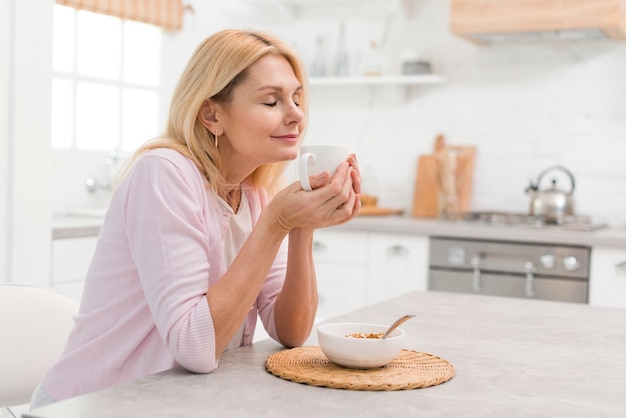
[{"xmin": 24, "ymin": 292, "xmax": 626, "ymax": 418}]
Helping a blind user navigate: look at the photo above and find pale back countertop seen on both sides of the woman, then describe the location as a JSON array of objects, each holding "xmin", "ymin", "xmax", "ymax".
[{"xmin": 52, "ymin": 215, "xmax": 626, "ymax": 248}]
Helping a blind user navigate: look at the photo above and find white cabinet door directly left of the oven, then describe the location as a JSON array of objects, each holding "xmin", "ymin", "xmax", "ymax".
[{"xmin": 368, "ymin": 233, "xmax": 429, "ymax": 303}]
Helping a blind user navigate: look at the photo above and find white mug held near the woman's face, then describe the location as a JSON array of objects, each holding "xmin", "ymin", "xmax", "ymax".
[{"xmin": 298, "ymin": 145, "xmax": 350, "ymax": 190}]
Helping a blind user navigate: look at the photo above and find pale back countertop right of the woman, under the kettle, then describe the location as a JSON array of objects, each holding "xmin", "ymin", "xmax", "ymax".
[{"xmin": 335, "ymin": 216, "xmax": 626, "ymax": 248}]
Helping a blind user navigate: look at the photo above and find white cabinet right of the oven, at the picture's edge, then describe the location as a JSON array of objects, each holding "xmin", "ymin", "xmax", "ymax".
[{"xmin": 589, "ymin": 247, "xmax": 626, "ymax": 308}]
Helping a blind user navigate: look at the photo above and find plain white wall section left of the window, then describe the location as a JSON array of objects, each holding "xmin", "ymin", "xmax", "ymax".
[{"xmin": 0, "ymin": 0, "xmax": 52, "ymax": 284}]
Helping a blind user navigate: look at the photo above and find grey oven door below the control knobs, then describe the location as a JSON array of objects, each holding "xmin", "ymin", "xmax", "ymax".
[{"xmin": 428, "ymin": 268, "xmax": 589, "ymax": 303}]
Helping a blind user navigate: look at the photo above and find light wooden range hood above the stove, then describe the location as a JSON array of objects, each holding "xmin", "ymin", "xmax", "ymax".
[{"xmin": 450, "ymin": 0, "xmax": 626, "ymax": 44}]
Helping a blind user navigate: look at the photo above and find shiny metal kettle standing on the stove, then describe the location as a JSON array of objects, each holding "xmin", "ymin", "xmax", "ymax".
[{"xmin": 526, "ymin": 165, "xmax": 574, "ymax": 224}]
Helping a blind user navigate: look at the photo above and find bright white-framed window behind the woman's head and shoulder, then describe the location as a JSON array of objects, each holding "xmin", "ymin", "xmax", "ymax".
[{"xmin": 52, "ymin": 5, "xmax": 161, "ymax": 152}]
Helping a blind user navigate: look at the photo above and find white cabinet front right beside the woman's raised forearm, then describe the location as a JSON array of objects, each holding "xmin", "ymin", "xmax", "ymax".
[{"xmin": 313, "ymin": 229, "xmax": 367, "ymax": 319}]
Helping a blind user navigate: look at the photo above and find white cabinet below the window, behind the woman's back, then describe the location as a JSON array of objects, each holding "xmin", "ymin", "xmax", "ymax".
[{"xmin": 50, "ymin": 236, "xmax": 98, "ymax": 302}]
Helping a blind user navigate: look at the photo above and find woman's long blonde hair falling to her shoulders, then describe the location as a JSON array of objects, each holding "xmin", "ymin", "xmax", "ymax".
[{"xmin": 116, "ymin": 29, "xmax": 308, "ymax": 195}]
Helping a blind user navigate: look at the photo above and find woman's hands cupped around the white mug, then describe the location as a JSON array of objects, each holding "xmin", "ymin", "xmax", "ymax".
[{"xmin": 264, "ymin": 162, "xmax": 361, "ymax": 232}]
